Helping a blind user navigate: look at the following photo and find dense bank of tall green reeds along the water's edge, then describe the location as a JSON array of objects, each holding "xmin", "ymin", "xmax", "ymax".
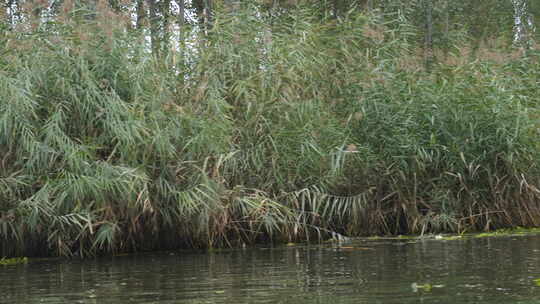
[{"xmin": 0, "ymin": 1, "xmax": 540, "ymax": 256}]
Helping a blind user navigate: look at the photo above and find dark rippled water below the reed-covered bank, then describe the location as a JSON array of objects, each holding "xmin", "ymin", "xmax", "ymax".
[{"xmin": 0, "ymin": 235, "xmax": 540, "ymax": 304}]
